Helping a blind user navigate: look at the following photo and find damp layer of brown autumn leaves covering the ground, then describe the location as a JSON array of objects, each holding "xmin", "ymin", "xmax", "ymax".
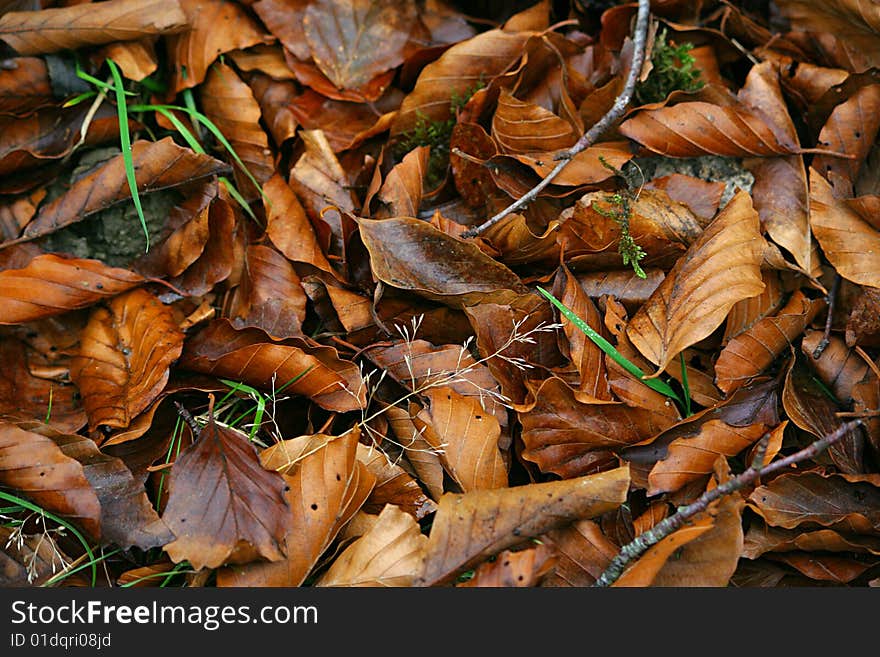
[{"xmin": 0, "ymin": 0, "xmax": 880, "ymax": 587}]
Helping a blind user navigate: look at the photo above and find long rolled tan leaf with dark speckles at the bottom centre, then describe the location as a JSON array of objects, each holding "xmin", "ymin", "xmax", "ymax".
[{"xmin": 414, "ymin": 467, "xmax": 629, "ymax": 586}]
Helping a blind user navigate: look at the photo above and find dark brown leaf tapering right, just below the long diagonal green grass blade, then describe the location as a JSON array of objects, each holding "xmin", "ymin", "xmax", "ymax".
[{"xmin": 519, "ymin": 377, "xmax": 678, "ymax": 478}]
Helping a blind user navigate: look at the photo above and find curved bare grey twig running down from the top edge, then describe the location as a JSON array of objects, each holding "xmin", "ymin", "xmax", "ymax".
[{"xmin": 462, "ymin": 0, "xmax": 651, "ymax": 239}]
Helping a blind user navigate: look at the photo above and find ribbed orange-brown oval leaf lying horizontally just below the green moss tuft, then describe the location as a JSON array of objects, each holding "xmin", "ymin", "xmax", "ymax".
[{"xmin": 620, "ymin": 101, "xmax": 801, "ymax": 157}]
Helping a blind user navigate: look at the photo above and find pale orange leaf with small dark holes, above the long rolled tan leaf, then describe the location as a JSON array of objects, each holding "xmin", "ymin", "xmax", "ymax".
[{"xmin": 415, "ymin": 387, "xmax": 507, "ymax": 493}]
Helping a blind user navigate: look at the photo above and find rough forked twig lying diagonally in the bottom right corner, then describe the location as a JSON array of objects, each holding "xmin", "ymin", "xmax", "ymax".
[{"xmin": 593, "ymin": 419, "xmax": 865, "ymax": 587}]
